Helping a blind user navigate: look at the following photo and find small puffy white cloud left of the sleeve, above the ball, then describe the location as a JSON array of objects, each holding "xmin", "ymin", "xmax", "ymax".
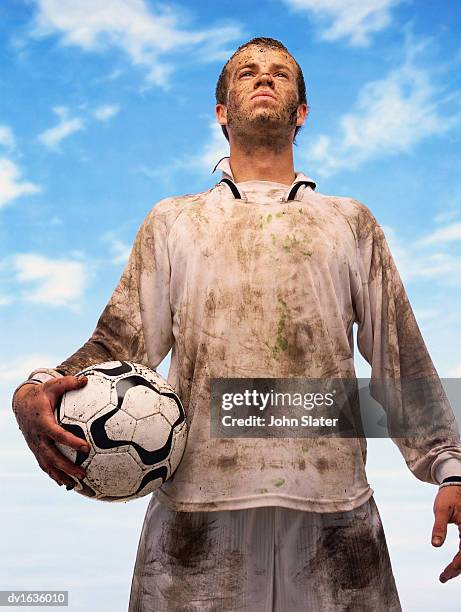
[{"xmin": 12, "ymin": 253, "xmax": 88, "ymax": 307}]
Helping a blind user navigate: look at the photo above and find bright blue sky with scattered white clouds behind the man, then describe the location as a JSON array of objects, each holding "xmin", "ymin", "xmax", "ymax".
[{"xmin": 0, "ymin": 0, "xmax": 461, "ymax": 611}]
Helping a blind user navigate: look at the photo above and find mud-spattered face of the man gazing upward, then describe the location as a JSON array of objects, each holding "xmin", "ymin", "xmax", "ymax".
[{"xmin": 220, "ymin": 45, "xmax": 302, "ymax": 148}]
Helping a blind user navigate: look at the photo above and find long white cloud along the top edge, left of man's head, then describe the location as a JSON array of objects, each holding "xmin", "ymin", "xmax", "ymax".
[{"xmin": 32, "ymin": 0, "xmax": 241, "ymax": 87}]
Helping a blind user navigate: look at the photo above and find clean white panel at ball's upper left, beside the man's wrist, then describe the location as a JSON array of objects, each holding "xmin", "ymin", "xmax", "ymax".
[{"xmin": 60, "ymin": 375, "xmax": 112, "ymax": 423}]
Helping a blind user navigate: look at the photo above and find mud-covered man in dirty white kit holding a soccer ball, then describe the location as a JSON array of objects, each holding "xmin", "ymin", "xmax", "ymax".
[{"xmin": 14, "ymin": 38, "xmax": 461, "ymax": 612}]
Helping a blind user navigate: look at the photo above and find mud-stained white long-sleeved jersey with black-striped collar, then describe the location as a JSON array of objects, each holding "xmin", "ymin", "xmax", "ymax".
[{"xmin": 42, "ymin": 158, "xmax": 461, "ymax": 512}]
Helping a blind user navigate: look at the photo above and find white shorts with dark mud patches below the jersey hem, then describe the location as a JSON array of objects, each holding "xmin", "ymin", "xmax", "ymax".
[{"xmin": 129, "ymin": 496, "xmax": 401, "ymax": 612}]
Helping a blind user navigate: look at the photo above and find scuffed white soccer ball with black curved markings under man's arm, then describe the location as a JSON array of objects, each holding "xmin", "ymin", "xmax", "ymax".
[{"xmin": 55, "ymin": 361, "xmax": 187, "ymax": 502}]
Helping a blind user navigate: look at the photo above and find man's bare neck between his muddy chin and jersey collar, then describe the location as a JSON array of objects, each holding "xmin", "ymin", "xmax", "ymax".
[{"xmin": 229, "ymin": 142, "xmax": 295, "ymax": 185}]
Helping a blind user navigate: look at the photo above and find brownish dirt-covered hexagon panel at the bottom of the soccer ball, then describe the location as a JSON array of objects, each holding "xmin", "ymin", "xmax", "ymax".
[{"xmin": 86, "ymin": 453, "xmax": 143, "ymax": 497}]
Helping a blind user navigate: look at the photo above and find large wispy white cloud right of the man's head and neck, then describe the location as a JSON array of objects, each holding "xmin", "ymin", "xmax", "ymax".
[{"xmin": 306, "ymin": 43, "xmax": 461, "ymax": 176}]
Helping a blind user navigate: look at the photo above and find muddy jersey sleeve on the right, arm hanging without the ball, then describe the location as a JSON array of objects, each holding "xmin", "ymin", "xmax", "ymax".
[{"xmin": 354, "ymin": 205, "xmax": 461, "ymax": 484}]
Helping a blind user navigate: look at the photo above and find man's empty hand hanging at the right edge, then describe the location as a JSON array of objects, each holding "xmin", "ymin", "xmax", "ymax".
[{"xmin": 432, "ymin": 485, "xmax": 461, "ymax": 582}]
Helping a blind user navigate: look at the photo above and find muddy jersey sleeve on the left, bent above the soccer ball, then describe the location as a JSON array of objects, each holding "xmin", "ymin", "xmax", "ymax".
[{"xmin": 56, "ymin": 207, "xmax": 173, "ymax": 374}]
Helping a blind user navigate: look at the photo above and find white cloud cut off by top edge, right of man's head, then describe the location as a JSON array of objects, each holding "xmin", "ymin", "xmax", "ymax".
[{"xmin": 278, "ymin": 0, "xmax": 402, "ymax": 46}]
